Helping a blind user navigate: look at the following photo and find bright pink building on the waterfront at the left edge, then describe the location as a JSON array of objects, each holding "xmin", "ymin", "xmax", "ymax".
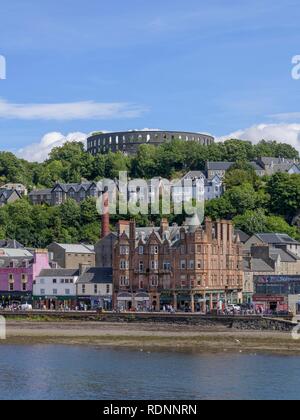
[{"xmin": 0, "ymin": 249, "xmax": 50, "ymax": 307}]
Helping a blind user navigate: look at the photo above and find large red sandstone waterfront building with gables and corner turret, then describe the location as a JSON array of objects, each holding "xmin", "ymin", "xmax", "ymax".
[{"xmin": 113, "ymin": 219, "xmax": 243, "ymax": 313}]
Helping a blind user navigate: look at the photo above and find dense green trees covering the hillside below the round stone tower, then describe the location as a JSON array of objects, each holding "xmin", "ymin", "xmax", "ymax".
[{"xmin": 0, "ymin": 140, "xmax": 300, "ymax": 247}]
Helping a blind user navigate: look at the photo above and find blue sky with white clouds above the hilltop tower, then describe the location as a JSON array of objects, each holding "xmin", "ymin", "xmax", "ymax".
[{"xmin": 0, "ymin": 0, "xmax": 300, "ymax": 159}]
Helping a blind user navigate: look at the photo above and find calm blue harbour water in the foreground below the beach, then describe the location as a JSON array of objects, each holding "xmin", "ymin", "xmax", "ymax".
[{"xmin": 0, "ymin": 345, "xmax": 300, "ymax": 400}]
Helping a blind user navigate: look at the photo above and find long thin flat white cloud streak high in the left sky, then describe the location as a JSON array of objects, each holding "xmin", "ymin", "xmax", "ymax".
[{"xmin": 0, "ymin": 99, "xmax": 146, "ymax": 121}]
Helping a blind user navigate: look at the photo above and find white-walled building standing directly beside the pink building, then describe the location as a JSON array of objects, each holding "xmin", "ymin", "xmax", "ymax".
[{"xmin": 33, "ymin": 269, "xmax": 79, "ymax": 309}]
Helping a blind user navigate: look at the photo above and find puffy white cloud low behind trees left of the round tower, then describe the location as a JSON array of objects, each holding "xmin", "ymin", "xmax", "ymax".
[{"xmin": 16, "ymin": 132, "xmax": 88, "ymax": 162}]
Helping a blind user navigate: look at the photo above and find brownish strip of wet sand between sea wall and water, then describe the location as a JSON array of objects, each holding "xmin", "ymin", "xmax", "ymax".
[{"xmin": 0, "ymin": 320, "xmax": 300, "ymax": 355}]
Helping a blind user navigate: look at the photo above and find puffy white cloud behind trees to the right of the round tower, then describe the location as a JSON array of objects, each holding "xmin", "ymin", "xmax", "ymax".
[{"xmin": 217, "ymin": 124, "xmax": 300, "ymax": 151}]
